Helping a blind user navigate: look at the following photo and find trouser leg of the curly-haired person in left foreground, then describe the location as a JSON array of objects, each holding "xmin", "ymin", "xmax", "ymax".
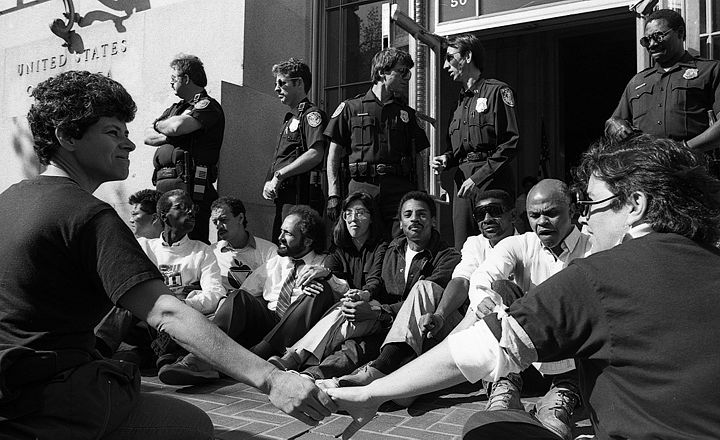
[{"xmin": 102, "ymin": 393, "xmax": 213, "ymax": 440}]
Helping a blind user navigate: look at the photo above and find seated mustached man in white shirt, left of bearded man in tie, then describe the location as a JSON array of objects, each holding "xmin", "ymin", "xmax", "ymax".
[{"xmin": 210, "ymin": 197, "xmax": 277, "ymax": 290}]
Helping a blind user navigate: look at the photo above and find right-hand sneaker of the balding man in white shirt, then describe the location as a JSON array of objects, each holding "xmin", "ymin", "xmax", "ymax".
[{"xmin": 531, "ymin": 387, "xmax": 580, "ymax": 440}]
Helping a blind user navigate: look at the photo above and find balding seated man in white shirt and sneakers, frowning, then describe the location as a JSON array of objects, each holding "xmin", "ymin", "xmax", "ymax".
[{"xmin": 468, "ymin": 179, "xmax": 590, "ymax": 439}]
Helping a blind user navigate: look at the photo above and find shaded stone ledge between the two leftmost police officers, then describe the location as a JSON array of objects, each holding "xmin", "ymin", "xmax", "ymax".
[{"xmin": 218, "ymin": 81, "xmax": 288, "ymax": 240}]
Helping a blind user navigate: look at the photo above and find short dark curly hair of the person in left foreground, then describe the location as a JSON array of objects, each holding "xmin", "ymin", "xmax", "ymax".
[{"xmin": 27, "ymin": 70, "xmax": 137, "ymax": 165}]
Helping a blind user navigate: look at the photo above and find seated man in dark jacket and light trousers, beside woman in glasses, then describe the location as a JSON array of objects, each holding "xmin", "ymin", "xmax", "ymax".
[{"xmin": 322, "ymin": 191, "xmax": 462, "ymax": 387}]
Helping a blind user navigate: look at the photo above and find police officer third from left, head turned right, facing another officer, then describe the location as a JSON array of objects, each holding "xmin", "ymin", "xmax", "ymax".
[{"xmin": 325, "ymin": 48, "xmax": 430, "ymax": 236}]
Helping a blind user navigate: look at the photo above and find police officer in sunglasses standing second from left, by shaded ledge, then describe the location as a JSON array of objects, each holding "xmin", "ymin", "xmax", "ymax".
[{"xmin": 263, "ymin": 58, "xmax": 327, "ymax": 244}]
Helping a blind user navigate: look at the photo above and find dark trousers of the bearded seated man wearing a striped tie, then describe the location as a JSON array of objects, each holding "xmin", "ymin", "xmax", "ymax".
[{"xmin": 213, "ymin": 284, "xmax": 334, "ymax": 359}]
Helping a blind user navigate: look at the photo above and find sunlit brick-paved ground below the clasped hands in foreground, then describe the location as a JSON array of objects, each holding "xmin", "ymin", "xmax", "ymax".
[{"xmin": 142, "ymin": 376, "xmax": 588, "ymax": 440}]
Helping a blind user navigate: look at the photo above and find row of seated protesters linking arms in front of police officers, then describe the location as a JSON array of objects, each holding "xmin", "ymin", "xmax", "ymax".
[{"xmin": 96, "ymin": 174, "xmax": 590, "ymax": 438}]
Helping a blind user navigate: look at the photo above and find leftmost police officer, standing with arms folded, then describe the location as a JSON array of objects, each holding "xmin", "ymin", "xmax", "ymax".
[{"xmin": 145, "ymin": 55, "xmax": 225, "ymax": 244}]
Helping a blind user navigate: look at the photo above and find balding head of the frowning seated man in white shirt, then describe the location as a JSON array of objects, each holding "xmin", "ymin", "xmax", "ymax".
[{"xmin": 526, "ymin": 179, "xmax": 573, "ymax": 255}]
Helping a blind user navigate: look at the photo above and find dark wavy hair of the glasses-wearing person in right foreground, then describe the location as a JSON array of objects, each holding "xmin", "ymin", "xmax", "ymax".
[{"xmin": 575, "ymin": 135, "xmax": 720, "ymax": 245}]
